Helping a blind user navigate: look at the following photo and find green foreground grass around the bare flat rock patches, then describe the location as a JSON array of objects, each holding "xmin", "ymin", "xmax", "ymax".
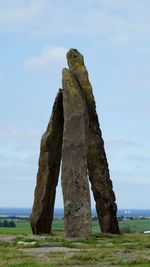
[{"xmin": 0, "ymin": 232, "xmax": 150, "ymax": 267}]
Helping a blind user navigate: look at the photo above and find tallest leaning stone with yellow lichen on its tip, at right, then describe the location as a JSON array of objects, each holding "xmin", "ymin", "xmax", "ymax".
[{"xmin": 67, "ymin": 49, "xmax": 119, "ymax": 234}]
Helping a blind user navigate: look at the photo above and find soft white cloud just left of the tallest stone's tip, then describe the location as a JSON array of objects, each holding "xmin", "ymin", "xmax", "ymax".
[{"xmin": 25, "ymin": 46, "xmax": 67, "ymax": 71}]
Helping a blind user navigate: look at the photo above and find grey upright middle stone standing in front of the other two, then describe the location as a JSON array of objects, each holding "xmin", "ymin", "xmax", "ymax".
[{"xmin": 62, "ymin": 69, "xmax": 91, "ymax": 237}]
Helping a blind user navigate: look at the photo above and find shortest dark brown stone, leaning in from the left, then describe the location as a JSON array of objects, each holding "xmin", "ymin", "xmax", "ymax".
[{"xmin": 30, "ymin": 90, "xmax": 63, "ymax": 234}]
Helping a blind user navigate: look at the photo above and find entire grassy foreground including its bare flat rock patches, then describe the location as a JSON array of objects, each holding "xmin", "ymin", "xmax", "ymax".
[{"xmin": 0, "ymin": 233, "xmax": 150, "ymax": 267}]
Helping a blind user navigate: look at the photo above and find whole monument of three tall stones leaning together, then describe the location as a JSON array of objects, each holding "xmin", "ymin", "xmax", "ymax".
[{"xmin": 30, "ymin": 49, "xmax": 120, "ymax": 237}]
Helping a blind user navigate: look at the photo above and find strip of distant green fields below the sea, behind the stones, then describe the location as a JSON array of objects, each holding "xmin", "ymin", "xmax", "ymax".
[{"xmin": 0, "ymin": 219, "xmax": 150, "ymax": 234}]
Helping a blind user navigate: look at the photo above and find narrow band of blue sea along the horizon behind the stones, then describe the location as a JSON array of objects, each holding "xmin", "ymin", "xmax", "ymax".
[{"xmin": 0, "ymin": 208, "xmax": 150, "ymax": 218}]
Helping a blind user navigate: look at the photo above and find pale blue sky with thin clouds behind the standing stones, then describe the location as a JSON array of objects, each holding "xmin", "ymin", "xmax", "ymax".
[{"xmin": 0, "ymin": 0, "xmax": 150, "ymax": 208}]
